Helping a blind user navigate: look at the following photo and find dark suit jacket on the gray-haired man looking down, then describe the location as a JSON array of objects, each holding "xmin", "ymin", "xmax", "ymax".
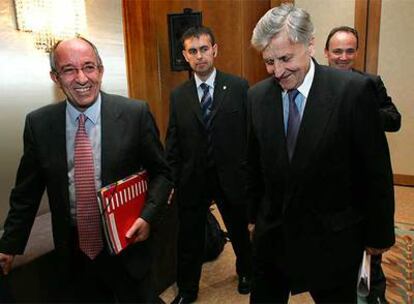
[{"xmin": 247, "ymin": 64, "xmax": 394, "ymax": 289}]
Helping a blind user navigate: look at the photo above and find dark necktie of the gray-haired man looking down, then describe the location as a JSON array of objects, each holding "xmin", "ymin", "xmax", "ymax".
[{"xmin": 286, "ymin": 89, "xmax": 300, "ymax": 160}]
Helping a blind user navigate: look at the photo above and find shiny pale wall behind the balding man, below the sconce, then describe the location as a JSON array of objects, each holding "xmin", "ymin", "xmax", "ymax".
[{"xmin": 0, "ymin": 0, "xmax": 128, "ymax": 226}]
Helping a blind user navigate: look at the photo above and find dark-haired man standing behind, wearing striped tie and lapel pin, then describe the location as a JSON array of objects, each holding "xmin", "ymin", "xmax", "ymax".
[{"xmin": 166, "ymin": 27, "xmax": 251, "ymax": 303}]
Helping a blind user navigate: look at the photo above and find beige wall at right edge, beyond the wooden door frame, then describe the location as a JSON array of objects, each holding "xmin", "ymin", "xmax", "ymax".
[{"xmin": 378, "ymin": 0, "xmax": 414, "ymax": 175}]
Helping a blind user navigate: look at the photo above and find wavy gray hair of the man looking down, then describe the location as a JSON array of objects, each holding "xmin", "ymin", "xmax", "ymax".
[{"xmin": 251, "ymin": 4, "xmax": 314, "ymax": 52}]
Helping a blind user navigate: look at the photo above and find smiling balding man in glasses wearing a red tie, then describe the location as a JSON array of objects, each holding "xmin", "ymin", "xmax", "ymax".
[{"xmin": 0, "ymin": 38, "xmax": 172, "ymax": 302}]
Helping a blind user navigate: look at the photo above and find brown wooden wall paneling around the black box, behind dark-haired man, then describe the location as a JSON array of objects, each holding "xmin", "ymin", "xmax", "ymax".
[{"xmin": 123, "ymin": 0, "xmax": 270, "ymax": 138}]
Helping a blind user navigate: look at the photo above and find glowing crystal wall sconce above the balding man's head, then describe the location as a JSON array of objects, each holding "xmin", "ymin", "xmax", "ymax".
[{"xmin": 14, "ymin": 0, "xmax": 86, "ymax": 52}]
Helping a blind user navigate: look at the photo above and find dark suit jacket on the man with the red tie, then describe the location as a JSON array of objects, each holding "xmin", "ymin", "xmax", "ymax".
[{"xmin": 0, "ymin": 92, "xmax": 172, "ymax": 276}]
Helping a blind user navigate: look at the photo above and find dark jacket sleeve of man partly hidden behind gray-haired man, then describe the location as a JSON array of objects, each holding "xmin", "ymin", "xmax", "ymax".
[{"xmin": 352, "ymin": 70, "xmax": 401, "ymax": 132}]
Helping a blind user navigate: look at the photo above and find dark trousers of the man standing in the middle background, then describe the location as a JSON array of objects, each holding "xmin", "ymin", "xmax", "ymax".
[{"xmin": 177, "ymin": 183, "xmax": 251, "ymax": 297}]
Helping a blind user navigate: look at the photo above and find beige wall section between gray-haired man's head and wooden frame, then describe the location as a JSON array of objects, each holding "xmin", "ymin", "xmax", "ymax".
[{"xmin": 295, "ymin": 0, "xmax": 355, "ymax": 64}]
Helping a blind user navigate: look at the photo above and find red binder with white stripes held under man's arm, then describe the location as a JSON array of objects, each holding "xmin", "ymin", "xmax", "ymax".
[{"xmin": 98, "ymin": 171, "xmax": 148, "ymax": 254}]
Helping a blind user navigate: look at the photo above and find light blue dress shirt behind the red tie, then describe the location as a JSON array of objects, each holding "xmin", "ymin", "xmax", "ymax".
[{"xmin": 66, "ymin": 94, "xmax": 102, "ymax": 225}]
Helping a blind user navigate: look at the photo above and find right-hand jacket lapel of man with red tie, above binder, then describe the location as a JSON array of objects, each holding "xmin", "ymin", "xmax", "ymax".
[{"xmin": 101, "ymin": 92, "xmax": 125, "ymax": 186}]
